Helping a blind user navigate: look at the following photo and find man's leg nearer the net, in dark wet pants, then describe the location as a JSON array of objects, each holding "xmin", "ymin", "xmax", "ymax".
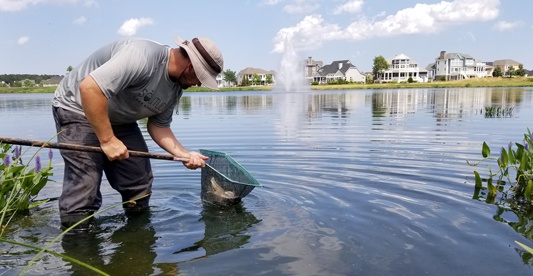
[{"xmin": 104, "ymin": 123, "xmax": 154, "ymax": 214}]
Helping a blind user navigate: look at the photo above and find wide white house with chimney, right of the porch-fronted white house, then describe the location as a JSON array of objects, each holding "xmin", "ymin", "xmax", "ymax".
[{"xmin": 430, "ymin": 51, "xmax": 488, "ymax": 80}]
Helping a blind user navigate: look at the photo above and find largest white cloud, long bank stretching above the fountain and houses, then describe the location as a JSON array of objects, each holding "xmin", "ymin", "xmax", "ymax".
[{"xmin": 272, "ymin": 0, "xmax": 500, "ymax": 53}]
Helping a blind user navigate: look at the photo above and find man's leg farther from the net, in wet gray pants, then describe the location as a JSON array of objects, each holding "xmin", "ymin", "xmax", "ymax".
[{"xmin": 53, "ymin": 107, "xmax": 106, "ymax": 230}]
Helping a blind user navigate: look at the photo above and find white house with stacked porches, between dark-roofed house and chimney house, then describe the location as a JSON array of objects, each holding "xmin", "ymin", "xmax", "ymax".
[{"xmin": 380, "ymin": 54, "xmax": 428, "ymax": 82}]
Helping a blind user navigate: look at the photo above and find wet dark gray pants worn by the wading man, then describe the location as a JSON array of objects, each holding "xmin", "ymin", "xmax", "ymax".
[{"xmin": 53, "ymin": 107, "xmax": 153, "ymax": 227}]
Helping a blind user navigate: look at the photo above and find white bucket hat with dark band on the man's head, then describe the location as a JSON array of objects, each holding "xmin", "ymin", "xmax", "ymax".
[{"xmin": 176, "ymin": 37, "xmax": 224, "ymax": 90}]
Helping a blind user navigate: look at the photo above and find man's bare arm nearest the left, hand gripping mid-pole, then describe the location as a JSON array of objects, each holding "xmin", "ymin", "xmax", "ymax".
[{"xmin": 80, "ymin": 76, "xmax": 129, "ymax": 160}]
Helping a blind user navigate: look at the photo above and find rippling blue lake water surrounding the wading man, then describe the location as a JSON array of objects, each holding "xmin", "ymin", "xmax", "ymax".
[{"xmin": 0, "ymin": 88, "xmax": 533, "ymax": 275}]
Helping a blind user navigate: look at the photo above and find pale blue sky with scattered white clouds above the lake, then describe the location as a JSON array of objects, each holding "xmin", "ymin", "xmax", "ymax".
[{"xmin": 0, "ymin": 0, "xmax": 533, "ymax": 75}]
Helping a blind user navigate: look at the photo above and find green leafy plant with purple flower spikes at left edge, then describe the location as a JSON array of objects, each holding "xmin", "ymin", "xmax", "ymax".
[{"xmin": 0, "ymin": 144, "xmax": 53, "ymax": 237}]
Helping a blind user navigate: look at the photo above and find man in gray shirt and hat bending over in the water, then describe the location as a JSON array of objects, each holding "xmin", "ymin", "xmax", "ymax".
[{"xmin": 52, "ymin": 38, "xmax": 223, "ymax": 231}]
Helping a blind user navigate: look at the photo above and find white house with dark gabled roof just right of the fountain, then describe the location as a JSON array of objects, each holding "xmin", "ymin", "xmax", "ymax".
[{"xmin": 313, "ymin": 60, "xmax": 366, "ymax": 84}]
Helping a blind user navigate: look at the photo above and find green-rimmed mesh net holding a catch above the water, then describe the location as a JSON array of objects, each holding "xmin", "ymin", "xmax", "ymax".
[{"xmin": 200, "ymin": 149, "xmax": 261, "ymax": 206}]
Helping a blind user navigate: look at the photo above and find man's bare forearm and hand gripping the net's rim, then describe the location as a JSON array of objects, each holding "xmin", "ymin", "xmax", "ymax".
[{"xmin": 148, "ymin": 123, "xmax": 208, "ymax": 170}]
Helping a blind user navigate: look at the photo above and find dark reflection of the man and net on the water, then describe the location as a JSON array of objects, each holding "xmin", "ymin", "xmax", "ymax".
[{"xmin": 61, "ymin": 204, "xmax": 261, "ymax": 275}]
